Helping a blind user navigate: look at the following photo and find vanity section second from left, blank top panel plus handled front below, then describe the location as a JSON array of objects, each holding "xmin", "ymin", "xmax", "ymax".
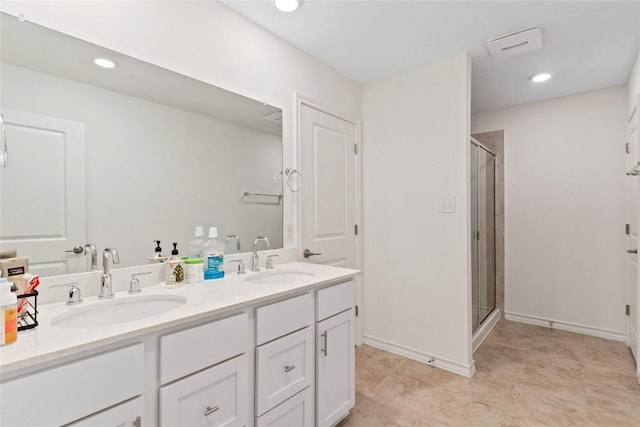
[{"xmin": 159, "ymin": 313, "xmax": 250, "ymax": 427}]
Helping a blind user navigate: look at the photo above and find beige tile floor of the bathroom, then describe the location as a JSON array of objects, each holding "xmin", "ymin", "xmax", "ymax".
[{"xmin": 339, "ymin": 320, "xmax": 640, "ymax": 427}]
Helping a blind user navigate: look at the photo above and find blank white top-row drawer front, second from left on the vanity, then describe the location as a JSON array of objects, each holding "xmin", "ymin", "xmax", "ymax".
[{"xmin": 160, "ymin": 313, "xmax": 249, "ymax": 384}]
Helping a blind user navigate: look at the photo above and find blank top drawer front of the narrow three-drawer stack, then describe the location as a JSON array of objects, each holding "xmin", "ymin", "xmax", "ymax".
[{"xmin": 256, "ymin": 294, "xmax": 313, "ymax": 345}]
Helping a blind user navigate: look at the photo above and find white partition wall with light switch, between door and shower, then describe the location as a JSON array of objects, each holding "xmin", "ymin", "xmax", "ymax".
[{"xmin": 363, "ymin": 55, "xmax": 473, "ymax": 375}]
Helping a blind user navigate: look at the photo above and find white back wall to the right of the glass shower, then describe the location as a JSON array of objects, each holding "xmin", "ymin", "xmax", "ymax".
[{"xmin": 471, "ymin": 86, "xmax": 627, "ymax": 339}]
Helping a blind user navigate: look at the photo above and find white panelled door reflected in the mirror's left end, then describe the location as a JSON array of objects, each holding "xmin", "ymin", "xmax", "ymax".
[{"xmin": 0, "ymin": 109, "xmax": 87, "ymax": 276}]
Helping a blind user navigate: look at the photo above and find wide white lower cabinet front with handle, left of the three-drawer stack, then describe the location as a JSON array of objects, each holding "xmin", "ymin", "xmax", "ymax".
[{"xmin": 160, "ymin": 355, "xmax": 249, "ymax": 427}]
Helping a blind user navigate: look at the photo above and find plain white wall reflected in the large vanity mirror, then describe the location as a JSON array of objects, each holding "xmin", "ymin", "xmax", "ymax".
[{"xmin": 1, "ymin": 63, "xmax": 282, "ymax": 266}]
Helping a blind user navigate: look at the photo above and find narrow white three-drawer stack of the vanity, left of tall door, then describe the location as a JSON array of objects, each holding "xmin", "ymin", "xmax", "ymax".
[{"xmin": 255, "ymin": 293, "xmax": 314, "ymax": 427}]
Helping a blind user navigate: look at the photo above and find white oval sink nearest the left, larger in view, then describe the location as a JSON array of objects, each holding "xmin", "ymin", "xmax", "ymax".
[{"xmin": 51, "ymin": 295, "xmax": 187, "ymax": 328}]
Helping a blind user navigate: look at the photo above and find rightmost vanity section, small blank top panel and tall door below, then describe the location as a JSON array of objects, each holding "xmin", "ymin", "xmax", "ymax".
[{"xmin": 316, "ymin": 281, "xmax": 355, "ymax": 427}]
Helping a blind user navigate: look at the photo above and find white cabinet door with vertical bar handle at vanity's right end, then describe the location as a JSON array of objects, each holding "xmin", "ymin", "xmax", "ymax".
[{"xmin": 316, "ymin": 308, "xmax": 356, "ymax": 427}]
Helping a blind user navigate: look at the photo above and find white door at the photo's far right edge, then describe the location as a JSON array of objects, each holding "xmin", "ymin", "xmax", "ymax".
[{"xmin": 627, "ymin": 98, "xmax": 640, "ymax": 363}]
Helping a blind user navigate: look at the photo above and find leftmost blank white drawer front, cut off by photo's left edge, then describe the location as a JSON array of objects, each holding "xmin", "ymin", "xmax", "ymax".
[{"xmin": 0, "ymin": 344, "xmax": 144, "ymax": 427}]
